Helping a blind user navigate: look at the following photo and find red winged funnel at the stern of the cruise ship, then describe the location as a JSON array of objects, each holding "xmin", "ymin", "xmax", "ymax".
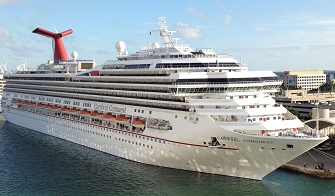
[{"xmin": 33, "ymin": 28, "xmax": 73, "ymax": 61}]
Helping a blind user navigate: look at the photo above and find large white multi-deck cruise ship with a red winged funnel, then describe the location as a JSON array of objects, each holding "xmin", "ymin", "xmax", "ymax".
[{"xmin": 1, "ymin": 17, "xmax": 328, "ymax": 180}]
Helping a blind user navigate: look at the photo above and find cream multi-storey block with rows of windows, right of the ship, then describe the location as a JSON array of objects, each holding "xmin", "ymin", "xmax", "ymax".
[{"xmin": 283, "ymin": 70, "xmax": 326, "ymax": 90}]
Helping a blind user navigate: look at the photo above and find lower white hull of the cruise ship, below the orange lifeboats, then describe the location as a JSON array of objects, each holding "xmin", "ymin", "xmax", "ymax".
[{"xmin": 4, "ymin": 106, "xmax": 324, "ymax": 180}]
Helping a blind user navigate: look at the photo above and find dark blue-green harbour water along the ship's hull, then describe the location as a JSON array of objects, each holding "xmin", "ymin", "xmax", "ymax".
[{"xmin": 0, "ymin": 116, "xmax": 335, "ymax": 196}]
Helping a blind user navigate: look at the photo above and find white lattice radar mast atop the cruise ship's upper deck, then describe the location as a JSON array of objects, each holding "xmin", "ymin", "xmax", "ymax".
[{"xmin": 150, "ymin": 16, "xmax": 178, "ymax": 47}]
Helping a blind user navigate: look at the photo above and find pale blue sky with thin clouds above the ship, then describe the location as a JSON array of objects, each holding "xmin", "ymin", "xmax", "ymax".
[{"xmin": 0, "ymin": 0, "xmax": 335, "ymax": 71}]
